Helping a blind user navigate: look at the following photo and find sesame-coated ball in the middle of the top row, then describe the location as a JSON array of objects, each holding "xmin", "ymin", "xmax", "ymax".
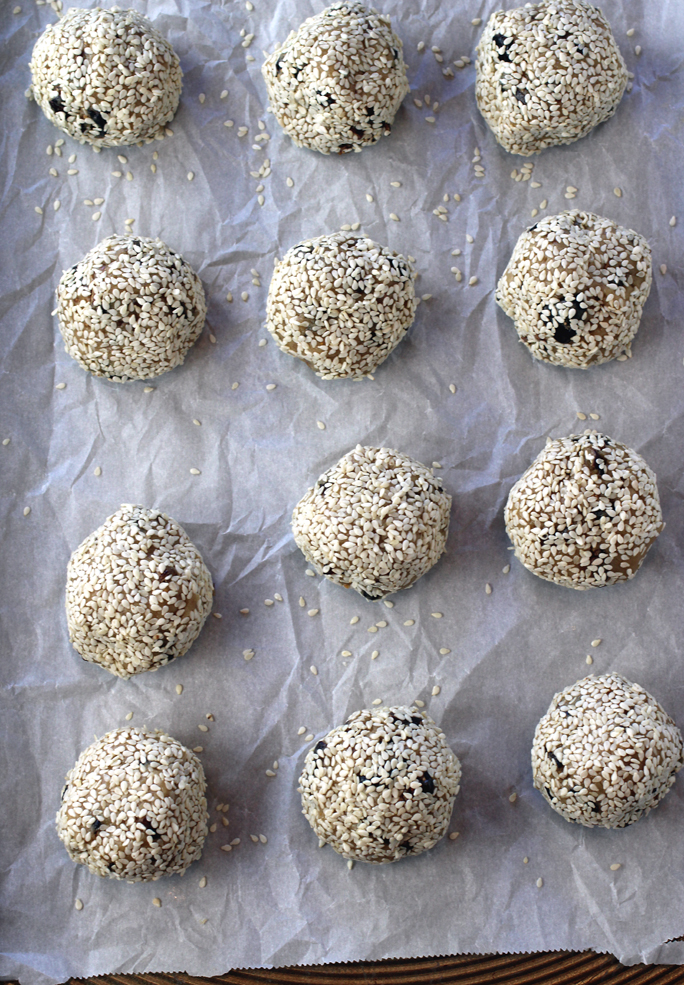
[{"xmin": 261, "ymin": 0, "xmax": 409, "ymax": 154}]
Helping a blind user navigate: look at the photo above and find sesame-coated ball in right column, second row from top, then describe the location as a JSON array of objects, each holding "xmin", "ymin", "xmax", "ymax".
[{"xmin": 496, "ymin": 209, "xmax": 651, "ymax": 369}]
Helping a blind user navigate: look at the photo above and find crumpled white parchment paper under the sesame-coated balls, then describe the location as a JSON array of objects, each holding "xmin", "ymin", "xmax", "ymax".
[{"xmin": 0, "ymin": 0, "xmax": 684, "ymax": 985}]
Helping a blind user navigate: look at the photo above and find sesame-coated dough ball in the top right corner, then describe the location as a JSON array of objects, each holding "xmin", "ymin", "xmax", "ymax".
[{"xmin": 475, "ymin": 0, "xmax": 627, "ymax": 157}]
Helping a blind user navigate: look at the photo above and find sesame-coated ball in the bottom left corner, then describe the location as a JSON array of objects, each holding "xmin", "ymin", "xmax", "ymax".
[{"xmin": 57, "ymin": 728, "xmax": 208, "ymax": 882}]
